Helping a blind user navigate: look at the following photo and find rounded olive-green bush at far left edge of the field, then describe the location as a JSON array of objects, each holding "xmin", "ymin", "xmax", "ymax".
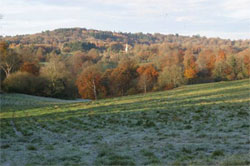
[{"xmin": 3, "ymin": 71, "xmax": 47, "ymax": 95}]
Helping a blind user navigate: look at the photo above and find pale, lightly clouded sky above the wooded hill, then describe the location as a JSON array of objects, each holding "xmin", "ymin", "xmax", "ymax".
[{"xmin": 0, "ymin": 0, "xmax": 250, "ymax": 40}]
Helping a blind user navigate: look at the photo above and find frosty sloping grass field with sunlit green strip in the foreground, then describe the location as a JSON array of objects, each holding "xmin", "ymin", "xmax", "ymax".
[{"xmin": 0, "ymin": 80, "xmax": 250, "ymax": 166}]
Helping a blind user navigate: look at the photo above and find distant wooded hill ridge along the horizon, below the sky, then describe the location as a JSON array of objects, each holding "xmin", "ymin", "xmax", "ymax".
[{"xmin": 0, "ymin": 28, "xmax": 250, "ymax": 51}]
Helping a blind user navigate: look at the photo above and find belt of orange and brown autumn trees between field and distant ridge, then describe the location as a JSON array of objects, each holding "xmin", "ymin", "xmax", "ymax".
[{"xmin": 0, "ymin": 31, "xmax": 250, "ymax": 99}]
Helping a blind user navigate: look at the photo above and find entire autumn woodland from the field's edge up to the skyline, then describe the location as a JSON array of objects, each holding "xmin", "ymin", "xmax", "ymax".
[{"xmin": 0, "ymin": 28, "xmax": 250, "ymax": 99}]
